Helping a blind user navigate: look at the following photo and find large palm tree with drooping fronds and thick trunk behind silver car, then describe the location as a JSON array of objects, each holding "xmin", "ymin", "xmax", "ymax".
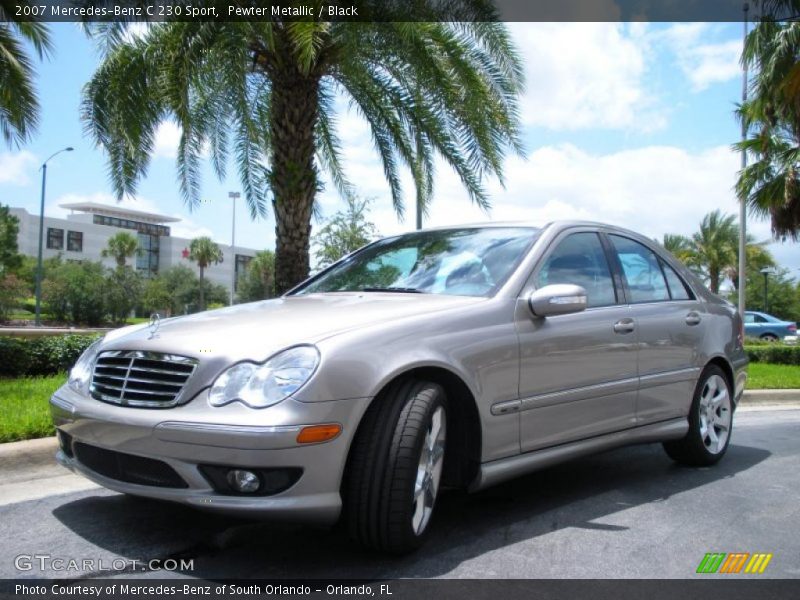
[{"xmin": 82, "ymin": 14, "xmax": 523, "ymax": 292}]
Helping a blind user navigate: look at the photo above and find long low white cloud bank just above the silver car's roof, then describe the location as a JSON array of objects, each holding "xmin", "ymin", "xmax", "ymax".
[{"xmin": 338, "ymin": 139, "xmax": 800, "ymax": 268}]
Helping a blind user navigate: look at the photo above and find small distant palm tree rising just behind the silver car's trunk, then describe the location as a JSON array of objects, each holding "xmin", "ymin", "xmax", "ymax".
[{"xmin": 688, "ymin": 210, "xmax": 739, "ymax": 294}]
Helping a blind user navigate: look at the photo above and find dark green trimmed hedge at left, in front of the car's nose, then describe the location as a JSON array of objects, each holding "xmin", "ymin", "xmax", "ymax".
[{"xmin": 0, "ymin": 335, "xmax": 98, "ymax": 377}]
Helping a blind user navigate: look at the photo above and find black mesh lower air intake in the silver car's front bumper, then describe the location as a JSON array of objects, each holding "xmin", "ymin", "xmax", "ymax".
[{"xmin": 72, "ymin": 442, "xmax": 189, "ymax": 488}]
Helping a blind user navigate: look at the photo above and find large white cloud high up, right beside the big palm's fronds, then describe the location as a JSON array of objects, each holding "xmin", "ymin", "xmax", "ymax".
[{"xmin": 509, "ymin": 23, "xmax": 666, "ymax": 131}]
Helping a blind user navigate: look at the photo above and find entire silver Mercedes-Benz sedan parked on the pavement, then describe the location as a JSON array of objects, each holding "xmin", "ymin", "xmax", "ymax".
[{"xmin": 51, "ymin": 222, "xmax": 747, "ymax": 552}]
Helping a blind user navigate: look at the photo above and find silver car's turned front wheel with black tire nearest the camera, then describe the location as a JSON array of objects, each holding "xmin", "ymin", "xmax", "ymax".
[{"xmin": 343, "ymin": 379, "xmax": 447, "ymax": 554}]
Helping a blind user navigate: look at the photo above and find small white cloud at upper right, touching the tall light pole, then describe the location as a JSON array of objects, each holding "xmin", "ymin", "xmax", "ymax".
[{"xmin": 655, "ymin": 23, "xmax": 742, "ymax": 92}]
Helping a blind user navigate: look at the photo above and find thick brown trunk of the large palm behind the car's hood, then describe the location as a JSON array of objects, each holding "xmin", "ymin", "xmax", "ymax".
[{"xmin": 270, "ymin": 57, "xmax": 319, "ymax": 294}]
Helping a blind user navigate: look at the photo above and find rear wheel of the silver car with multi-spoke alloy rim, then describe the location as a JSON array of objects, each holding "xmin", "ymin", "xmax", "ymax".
[{"xmin": 664, "ymin": 365, "xmax": 733, "ymax": 467}]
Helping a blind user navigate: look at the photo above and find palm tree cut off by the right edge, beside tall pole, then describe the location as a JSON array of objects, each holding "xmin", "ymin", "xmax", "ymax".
[{"xmin": 736, "ymin": 0, "xmax": 800, "ymax": 239}]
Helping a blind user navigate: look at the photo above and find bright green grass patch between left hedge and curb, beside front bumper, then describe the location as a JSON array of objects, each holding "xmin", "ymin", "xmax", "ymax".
[{"xmin": 0, "ymin": 373, "xmax": 67, "ymax": 442}]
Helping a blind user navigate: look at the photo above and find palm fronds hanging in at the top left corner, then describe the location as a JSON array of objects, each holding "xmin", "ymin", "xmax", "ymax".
[{"xmin": 0, "ymin": 0, "xmax": 51, "ymax": 146}]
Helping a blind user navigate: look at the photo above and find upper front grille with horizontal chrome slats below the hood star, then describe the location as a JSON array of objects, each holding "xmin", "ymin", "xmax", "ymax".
[{"xmin": 89, "ymin": 350, "xmax": 197, "ymax": 408}]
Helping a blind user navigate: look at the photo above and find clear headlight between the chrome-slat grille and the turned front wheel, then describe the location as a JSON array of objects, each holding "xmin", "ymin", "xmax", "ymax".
[{"xmin": 208, "ymin": 346, "xmax": 319, "ymax": 408}]
